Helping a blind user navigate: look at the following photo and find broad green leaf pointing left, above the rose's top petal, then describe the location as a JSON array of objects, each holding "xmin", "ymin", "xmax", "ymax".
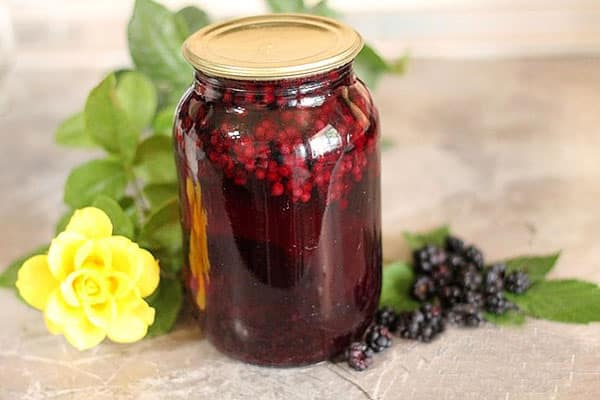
[{"xmin": 65, "ymin": 160, "xmax": 127, "ymax": 208}]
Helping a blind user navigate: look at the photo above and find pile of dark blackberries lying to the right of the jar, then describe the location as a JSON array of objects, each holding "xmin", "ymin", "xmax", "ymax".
[{"xmin": 346, "ymin": 236, "xmax": 531, "ymax": 371}]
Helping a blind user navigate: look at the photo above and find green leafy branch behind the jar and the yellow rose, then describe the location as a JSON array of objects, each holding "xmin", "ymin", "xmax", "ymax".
[{"xmin": 0, "ymin": 0, "xmax": 408, "ymax": 336}]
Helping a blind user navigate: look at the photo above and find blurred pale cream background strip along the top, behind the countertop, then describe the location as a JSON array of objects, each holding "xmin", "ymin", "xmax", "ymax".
[{"xmin": 0, "ymin": 0, "xmax": 600, "ymax": 68}]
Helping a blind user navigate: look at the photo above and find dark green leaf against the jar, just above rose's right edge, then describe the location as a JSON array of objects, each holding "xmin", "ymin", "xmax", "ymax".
[{"xmin": 139, "ymin": 199, "xmax": 182, "ymax": 254}]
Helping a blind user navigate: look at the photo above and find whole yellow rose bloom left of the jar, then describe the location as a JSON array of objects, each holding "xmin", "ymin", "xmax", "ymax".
[{"xmin": 16, "ymin": 207, "xmax": 159, "ymax": 350}]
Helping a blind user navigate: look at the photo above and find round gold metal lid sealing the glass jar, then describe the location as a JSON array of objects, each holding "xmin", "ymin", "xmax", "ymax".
[{"xmin": 183, "ymin": 14, "xmax": 363, "ymax": 80}]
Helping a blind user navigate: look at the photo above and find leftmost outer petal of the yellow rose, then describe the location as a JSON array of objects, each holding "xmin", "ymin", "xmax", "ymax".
[{"xmin": 16, "ymin": 255, "xmax": 58, "ymax": 310}]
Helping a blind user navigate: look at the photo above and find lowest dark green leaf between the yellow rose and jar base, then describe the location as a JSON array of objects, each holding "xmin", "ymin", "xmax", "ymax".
[{"xmin": 146, "ymin": 277, "xmax": 183, "ymax": 337}]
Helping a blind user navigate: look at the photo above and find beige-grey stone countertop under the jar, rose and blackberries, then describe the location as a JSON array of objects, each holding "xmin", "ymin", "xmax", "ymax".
[{"xmin": 0, "ymin": 58, "xmax": 600, "ymax": 400}]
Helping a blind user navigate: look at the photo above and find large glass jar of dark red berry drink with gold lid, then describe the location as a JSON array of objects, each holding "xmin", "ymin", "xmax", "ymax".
[{"xmin": 174, "ymin": 14, "xmax": 381, "ymax": 366}]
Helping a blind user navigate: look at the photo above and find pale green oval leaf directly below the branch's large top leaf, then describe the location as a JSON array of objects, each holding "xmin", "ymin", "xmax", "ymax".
[{"xmin": 116, "ymin": 72, "xmax": 158, "ymax": 132}]
